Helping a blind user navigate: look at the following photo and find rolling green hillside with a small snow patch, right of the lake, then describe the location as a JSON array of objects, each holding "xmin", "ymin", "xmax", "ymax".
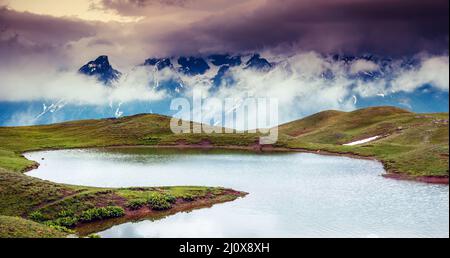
[{"xmin": 280, "ymin": 107, "xmax": 449, "ymax": 177}]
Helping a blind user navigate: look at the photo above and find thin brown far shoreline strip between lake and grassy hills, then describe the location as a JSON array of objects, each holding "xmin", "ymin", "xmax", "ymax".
[{"xmin": 22, "ymin": 140, "xmax": 449, "ymax": 185}]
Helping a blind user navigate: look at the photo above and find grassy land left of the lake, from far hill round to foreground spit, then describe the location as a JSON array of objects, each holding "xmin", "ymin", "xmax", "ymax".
[{"xmin": 0, "ymin": 115, "xmax": 250, "ymax": 237}]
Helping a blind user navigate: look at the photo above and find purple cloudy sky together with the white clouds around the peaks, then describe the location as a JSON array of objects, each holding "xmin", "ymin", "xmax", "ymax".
[{"xmin": 0, "ymin": 0, "xmax": 449, "ymax": 125}]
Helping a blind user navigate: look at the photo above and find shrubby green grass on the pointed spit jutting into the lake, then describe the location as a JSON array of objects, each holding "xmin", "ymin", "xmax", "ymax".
[{"xmin": 15, "ymin": 187, "xmax": 242, "ymax": 236}]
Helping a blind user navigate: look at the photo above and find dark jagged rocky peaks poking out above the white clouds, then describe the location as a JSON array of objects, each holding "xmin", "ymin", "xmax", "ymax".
[{"xmin": 79, "ymin": 53, "xmax": 420, "ymax": 87}]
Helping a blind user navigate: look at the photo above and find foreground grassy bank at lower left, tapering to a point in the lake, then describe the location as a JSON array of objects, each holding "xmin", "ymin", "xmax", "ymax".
[{"xmin": 0, "ymin": 154, "xmax": 246, "ymax": 237}]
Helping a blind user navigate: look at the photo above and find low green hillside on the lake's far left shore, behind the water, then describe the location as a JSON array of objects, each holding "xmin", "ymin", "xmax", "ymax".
[{"xmin": 0, "ymin": 114, "xmax": 258, "ymax": 171}]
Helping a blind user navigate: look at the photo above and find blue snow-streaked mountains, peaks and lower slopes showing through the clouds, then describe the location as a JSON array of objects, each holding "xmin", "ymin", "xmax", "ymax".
[{"xmin": 0, "ymin": 53, "xmax": 448, "ymax": 125}]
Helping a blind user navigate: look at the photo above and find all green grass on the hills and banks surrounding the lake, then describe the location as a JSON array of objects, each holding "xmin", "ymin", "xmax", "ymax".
[{"xmin": 0, "ymin": 107, "xmax": 449, "ymax": 237}]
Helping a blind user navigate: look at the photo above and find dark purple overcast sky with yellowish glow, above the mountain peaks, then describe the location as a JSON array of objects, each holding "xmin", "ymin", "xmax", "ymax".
[{"xmin": 0, "ymin": 0, "xmax": 449, "ymax": 69}]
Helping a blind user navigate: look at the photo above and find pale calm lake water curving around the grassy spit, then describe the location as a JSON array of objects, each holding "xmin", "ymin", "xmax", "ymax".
[{"xmin": 25, "ymin": 148, "xmax": 449, "ymax": 237}]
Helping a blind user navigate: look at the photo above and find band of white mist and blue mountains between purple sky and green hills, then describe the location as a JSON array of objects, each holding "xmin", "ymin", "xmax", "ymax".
[{"xmin": 0, "ymin": 52, "xmax": 448, "ymax": 125}]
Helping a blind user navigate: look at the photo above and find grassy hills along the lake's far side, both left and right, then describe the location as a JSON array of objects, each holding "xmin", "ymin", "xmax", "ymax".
[{"xmin": 0, "ymin": 107, "xmax": 449, "ymax": 176}]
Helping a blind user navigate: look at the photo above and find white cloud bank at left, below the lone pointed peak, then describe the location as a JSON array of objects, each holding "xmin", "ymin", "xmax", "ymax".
[{"xmin": 0, "ymin": 59, "xmax": 163, "ymax": 105}]
